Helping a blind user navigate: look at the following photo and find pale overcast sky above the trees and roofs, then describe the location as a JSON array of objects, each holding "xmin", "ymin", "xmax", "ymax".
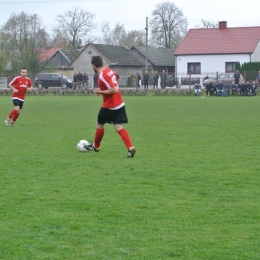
[{"xmin": 0, "ymin": 0, "xmax": 260, "ymax": 34}]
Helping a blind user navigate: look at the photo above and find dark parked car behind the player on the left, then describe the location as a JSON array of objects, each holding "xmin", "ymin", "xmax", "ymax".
[{"xmin": 35, "ymin": 73, "xmax": 73, "ymax": 89}]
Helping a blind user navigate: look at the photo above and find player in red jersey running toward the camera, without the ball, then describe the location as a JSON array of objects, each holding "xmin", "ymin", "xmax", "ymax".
[{"xmin": 4, "ymin": 68, "xmax": 33, "ymax": 126}]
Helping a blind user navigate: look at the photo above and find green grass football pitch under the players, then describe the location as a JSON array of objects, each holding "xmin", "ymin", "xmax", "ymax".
[{"xmin": 0, "ymin": 96, "xmax": 260, "ymax": 260}]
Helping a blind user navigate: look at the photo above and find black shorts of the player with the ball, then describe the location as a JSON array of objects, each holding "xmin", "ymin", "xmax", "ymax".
[{"xmin": 97, "ymin": 106, "xmax": 128, "ymax": 125}]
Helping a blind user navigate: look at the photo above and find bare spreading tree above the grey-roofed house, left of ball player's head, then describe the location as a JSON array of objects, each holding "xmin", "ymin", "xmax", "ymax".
[{"xmin": 54, "ymin": 7, "xmax": 96, "ymax": 49}]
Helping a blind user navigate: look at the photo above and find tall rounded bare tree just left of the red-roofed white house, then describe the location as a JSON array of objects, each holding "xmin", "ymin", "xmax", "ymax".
[{"xmin": 150, "ymin": 2, "xmax": 187, "ymax": 49}]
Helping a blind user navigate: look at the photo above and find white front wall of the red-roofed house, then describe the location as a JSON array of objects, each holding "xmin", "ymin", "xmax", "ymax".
[{"xmin": 175, "ymin": 54, "xmax": 250, "ymax": 76}]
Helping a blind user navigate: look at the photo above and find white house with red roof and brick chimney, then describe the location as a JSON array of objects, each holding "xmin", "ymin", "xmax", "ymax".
[{"xmin": 174, "ymin": 21, "xmax": 260, "ymax": 77}]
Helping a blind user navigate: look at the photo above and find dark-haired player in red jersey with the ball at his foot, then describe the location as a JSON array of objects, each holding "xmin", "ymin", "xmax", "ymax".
[{"xmin": 84, "ymin": 56, "xmax": 136, "ymax": 158}]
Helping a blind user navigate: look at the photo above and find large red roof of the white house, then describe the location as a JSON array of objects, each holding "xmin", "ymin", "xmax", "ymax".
[{"xmin": 174, "ymin": 26, "xmax": 260, "ymax": 55}]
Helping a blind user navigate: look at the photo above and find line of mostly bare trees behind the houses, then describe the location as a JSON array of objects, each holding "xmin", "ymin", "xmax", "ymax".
[{"xmin": 0, "ymin": 2, "xmax": 215, "ymax": 76}]
